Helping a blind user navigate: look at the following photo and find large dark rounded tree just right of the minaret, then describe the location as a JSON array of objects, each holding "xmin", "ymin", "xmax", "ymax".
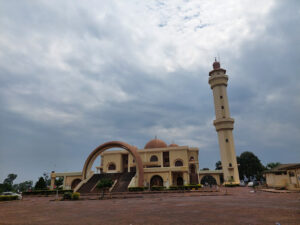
[{"xmin": 237, "ymin": 152, "xmax": 265, "ymax": 179}]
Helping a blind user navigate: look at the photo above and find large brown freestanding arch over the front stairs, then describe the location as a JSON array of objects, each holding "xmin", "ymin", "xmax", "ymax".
[{"xmin": 82, "ymin": 141, "xmax": 144, "ymax": 187}]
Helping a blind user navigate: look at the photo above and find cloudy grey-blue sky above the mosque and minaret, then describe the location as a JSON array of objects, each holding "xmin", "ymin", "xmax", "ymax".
[{"xmin": 0, "ymin": 0, "xmax": 300, "ymax": 182}]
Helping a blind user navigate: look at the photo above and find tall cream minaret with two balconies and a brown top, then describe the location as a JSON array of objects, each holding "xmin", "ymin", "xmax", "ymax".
[{"xmin": 208, "ymin": 59, "xmax": 240, "ymax": 184}]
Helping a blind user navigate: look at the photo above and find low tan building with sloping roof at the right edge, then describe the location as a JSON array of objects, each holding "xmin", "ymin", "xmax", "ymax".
[{"xmin": 264, "ymin": 163, "xmax": 300, "ymax": 190}]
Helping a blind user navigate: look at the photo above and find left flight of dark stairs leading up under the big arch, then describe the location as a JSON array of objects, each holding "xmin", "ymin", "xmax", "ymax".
[{"xmin": 78, "ymin": 173, "xmax": 121, "ymax": 193}]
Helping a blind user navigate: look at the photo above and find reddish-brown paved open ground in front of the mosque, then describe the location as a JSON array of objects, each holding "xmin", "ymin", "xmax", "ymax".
[{"xmin": 0, "ymin": 188, "xmax": 300, "ymax": 225}]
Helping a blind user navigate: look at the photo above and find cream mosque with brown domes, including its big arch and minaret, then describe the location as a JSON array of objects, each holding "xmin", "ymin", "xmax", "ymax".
[{"xmin": 51, "ymin": 61, "xmax": 240, "ymax": 193}]
